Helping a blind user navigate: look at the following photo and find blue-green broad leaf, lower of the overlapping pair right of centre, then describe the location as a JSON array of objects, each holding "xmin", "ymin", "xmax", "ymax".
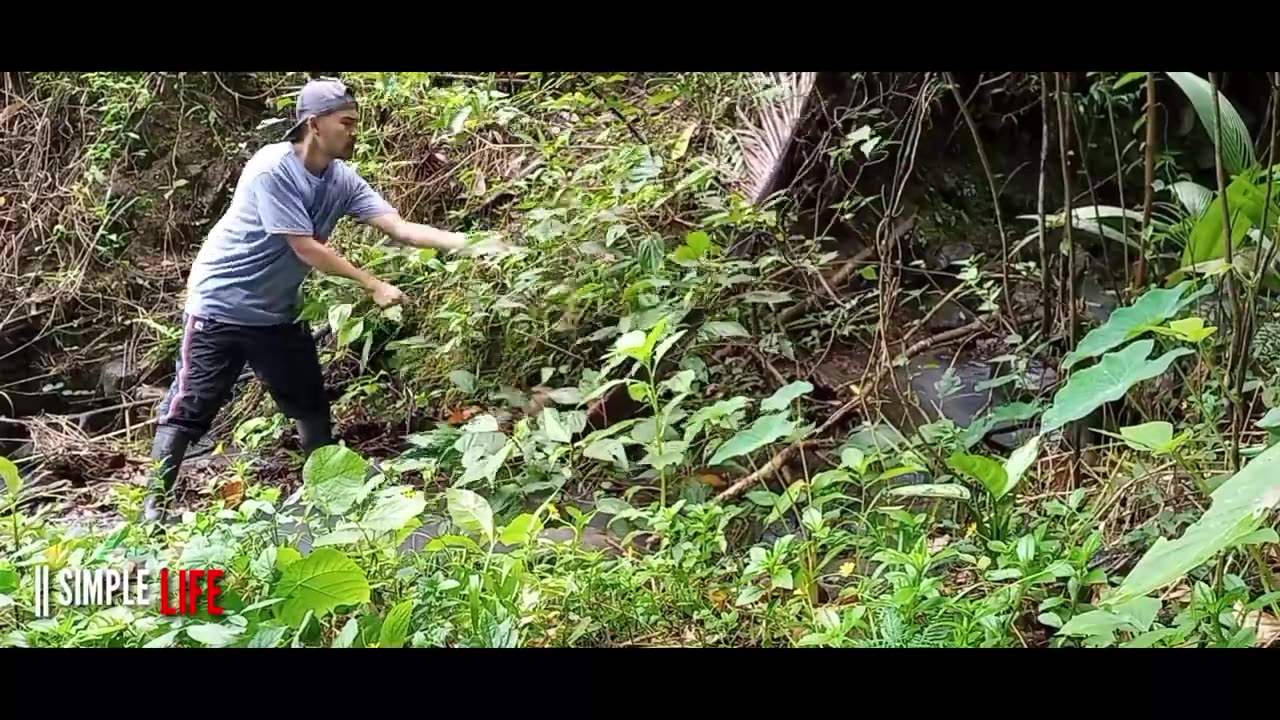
[{"xmin": 1041, "ymin": 340, "xmax": 1192, "ymax": 434}]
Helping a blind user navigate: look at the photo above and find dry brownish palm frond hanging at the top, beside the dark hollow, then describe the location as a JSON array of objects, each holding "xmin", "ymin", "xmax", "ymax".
[{"xmin": 736, "ymin": 73, "xmax": 818, "ymax": 204}]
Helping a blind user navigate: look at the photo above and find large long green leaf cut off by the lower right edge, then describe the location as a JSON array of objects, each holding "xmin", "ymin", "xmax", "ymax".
[{"xmin": 1103, "ymin": 446, "xmax": 1280, "ymax": 606}]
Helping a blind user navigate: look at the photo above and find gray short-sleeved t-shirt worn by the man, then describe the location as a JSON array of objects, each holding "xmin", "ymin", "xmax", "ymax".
[{"xmin": 186, "ymin": 142, "xmax": 396, "ymax": 325}]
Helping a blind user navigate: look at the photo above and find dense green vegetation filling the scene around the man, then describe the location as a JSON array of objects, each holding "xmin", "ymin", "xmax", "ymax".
[{"xmin": 0, "ymin": 73, "xmax": 1280, "ymax": 647}]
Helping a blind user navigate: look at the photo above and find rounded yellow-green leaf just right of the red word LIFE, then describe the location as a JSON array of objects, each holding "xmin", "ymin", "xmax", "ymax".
[{"xmin": 275, "ymin": 547, "xmax": 370, "ymax": 628}]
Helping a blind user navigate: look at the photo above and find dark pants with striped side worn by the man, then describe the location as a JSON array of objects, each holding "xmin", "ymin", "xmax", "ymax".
[{"xmin": 159, "ymin": 315, "xmax": 329, "ymax": 442}]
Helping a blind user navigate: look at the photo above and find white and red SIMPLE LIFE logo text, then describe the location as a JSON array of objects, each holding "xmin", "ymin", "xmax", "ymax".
[{"xmin": 35, "ymin": 565, "xmax": 223, "ymax": 618}]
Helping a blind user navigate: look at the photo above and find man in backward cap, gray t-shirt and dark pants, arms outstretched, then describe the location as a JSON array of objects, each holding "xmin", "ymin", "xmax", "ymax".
[{"xmin": 143, "ymin": 79, "xmax": 500, "ymax": 521}]
